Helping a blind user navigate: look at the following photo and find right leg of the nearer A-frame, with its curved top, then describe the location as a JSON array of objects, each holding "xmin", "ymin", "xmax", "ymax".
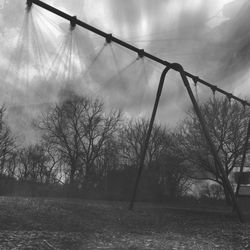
[{"xmin": 172, "ymin": 63, "xmax": 243, "ymax": 222}]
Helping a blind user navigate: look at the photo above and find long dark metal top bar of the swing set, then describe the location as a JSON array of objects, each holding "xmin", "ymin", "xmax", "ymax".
[{"xmin": 27, "ymin": 0, "xmax": 250, "ymax": 107}]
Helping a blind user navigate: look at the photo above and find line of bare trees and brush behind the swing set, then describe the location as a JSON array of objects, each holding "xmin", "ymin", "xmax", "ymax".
[{"xmin": 0, "ymin": 93, "xmax": 249, "ymax": 200}]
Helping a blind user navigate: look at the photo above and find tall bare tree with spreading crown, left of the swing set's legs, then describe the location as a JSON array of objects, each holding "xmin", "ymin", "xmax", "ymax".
[{"xmin": 38, "ymin": 95, "xmax": 121, "ymax": 188}]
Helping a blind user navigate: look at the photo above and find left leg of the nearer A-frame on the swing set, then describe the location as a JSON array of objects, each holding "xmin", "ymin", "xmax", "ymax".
[{"xmin": 129, "ymin": 67, "xmax": 170, "ymax": 210}]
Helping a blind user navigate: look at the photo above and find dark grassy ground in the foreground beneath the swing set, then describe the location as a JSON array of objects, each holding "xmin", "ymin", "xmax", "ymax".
[{"xmin": 0, "ymin": 198, "xmax": 250, "ymax": 250}]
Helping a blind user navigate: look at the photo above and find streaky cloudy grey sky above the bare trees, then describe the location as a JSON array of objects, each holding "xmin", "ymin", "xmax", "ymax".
[{"xmin": 0, "ymin": 0, "xmax": 250, "ymax": 143}]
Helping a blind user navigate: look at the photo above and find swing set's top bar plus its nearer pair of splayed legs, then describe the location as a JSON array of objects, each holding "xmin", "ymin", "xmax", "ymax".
[{"xmin": 26, "ymin": 0, "xmax": 247, "ymax": 222}]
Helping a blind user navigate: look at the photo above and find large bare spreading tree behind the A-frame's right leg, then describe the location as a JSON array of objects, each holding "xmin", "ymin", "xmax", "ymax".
[{"xmin": 175, "ymin": 98, "xmax": 249, "ymax": 202}]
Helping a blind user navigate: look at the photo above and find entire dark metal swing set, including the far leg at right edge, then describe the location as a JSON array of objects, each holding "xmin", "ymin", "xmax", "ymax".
[{"xmin": 10, "ymin": 0, "xmax": 250, "ymax": 222}]
